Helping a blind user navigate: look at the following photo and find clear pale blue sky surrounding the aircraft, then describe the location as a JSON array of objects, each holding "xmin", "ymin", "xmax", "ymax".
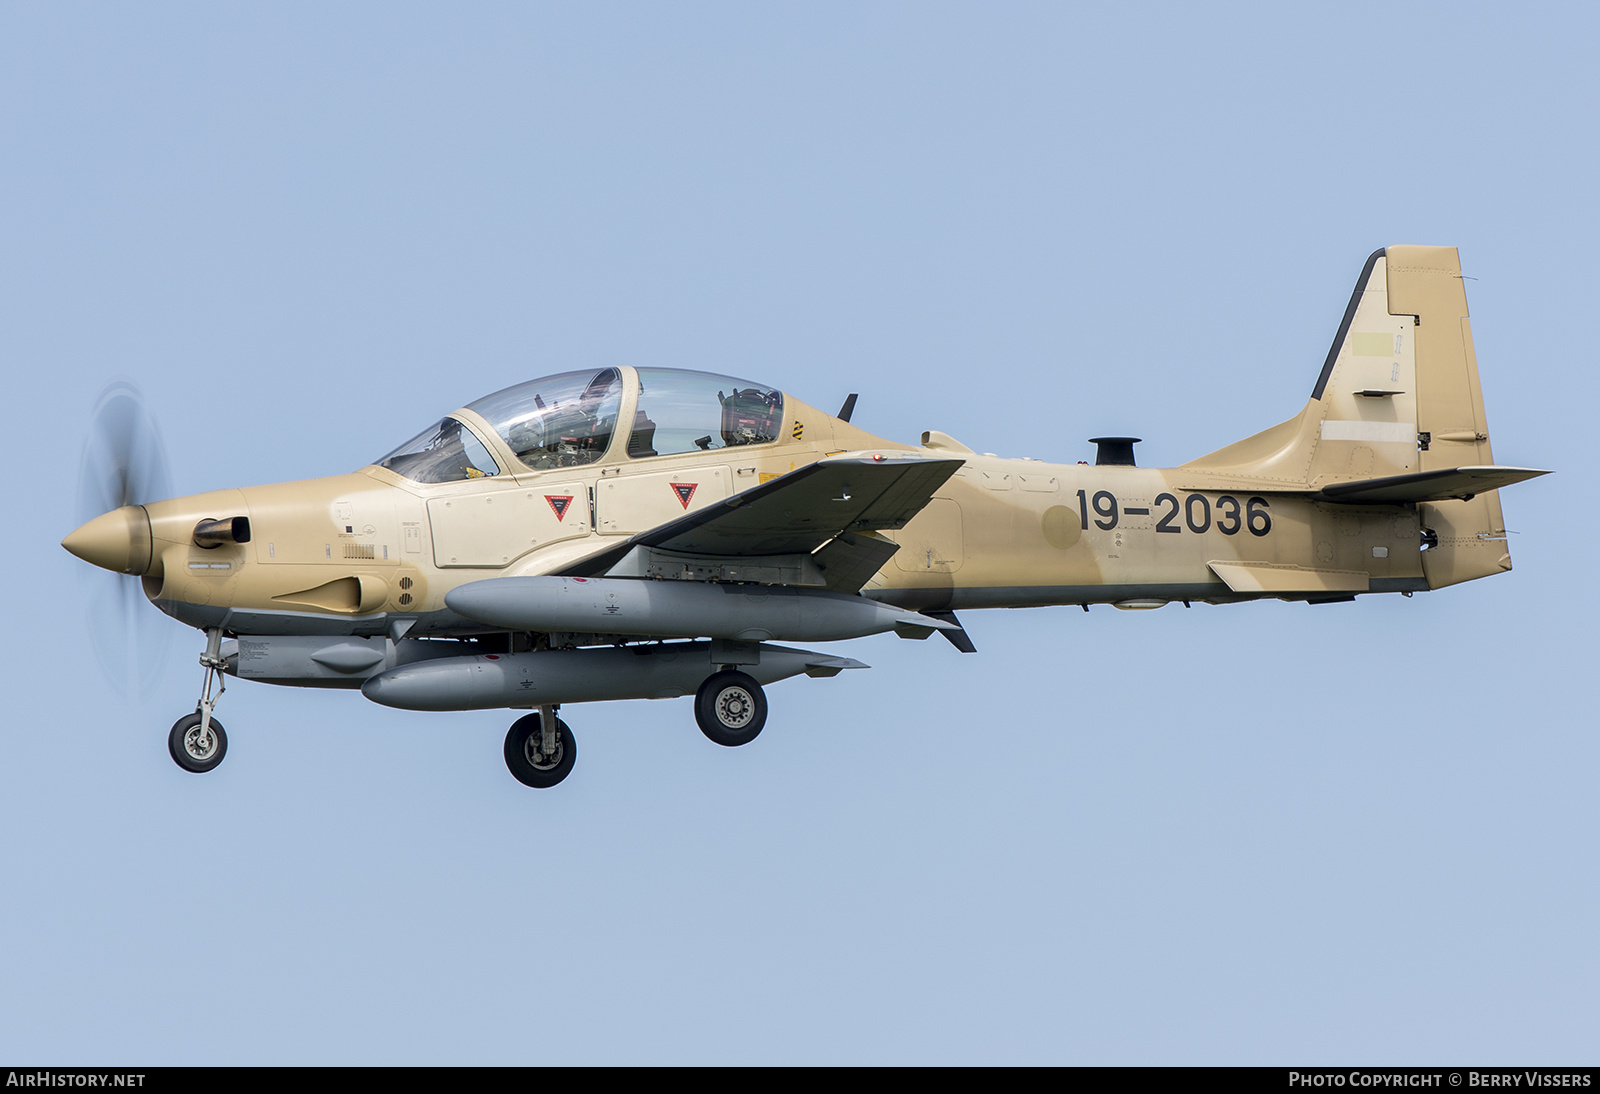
[{"xmin": 0, "ymin": 2, "xmax": 1600, "ymax": 1064}]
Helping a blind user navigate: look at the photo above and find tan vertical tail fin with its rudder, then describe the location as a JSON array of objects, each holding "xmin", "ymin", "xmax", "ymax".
[{"xmin": 1184, "ymin": 246, "xmax": 1510, "ymax": 589}]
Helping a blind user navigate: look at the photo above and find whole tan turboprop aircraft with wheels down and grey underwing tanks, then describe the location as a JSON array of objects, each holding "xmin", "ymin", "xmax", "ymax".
[{"xmin": 62, "ymin": 246, "xmax": 1546, "ymax": 787}]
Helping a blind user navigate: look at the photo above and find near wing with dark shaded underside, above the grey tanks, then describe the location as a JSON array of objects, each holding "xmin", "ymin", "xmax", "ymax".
[{"xmin": 557, "ymin": 456, "xmax": 963, "ymax": 592}]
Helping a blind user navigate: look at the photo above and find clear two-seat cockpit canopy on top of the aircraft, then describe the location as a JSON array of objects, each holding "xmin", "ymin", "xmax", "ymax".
[{"xmin": 378, "ymin": 368, "xmax": 784, "ymax": 483}]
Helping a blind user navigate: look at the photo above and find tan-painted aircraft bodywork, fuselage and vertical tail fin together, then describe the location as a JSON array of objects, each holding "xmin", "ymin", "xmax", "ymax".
[{"xmin": 75, "ymin": 248, "xmax": 1538, "ymax": 637}]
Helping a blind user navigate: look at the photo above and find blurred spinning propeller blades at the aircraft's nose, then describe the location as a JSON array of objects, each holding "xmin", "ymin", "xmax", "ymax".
[{"xmin": 77, "ymin": 382, "xmax": 171, "ymax": 699}]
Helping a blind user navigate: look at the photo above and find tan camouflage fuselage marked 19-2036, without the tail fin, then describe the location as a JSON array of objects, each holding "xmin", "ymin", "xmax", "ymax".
[{"xmin": 131, "ymin": 431, "xmax": 1448, "ymax": 637}]
